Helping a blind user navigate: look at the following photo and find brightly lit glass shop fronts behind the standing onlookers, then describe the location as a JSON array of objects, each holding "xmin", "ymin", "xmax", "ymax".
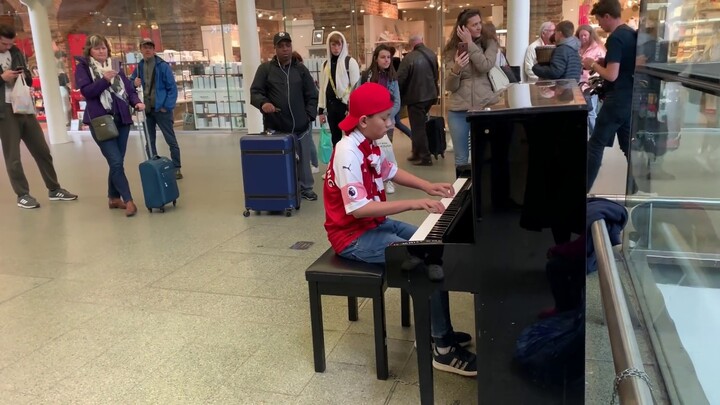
[{"xmin": 7, "ymin": 0, "xmax": 638, "ymax": 130}]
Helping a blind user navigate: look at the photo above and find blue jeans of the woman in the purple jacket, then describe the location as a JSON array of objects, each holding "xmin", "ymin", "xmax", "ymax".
[{"xmin": 90, "ymin": 120, "xmax": 132, "ymax": 201}]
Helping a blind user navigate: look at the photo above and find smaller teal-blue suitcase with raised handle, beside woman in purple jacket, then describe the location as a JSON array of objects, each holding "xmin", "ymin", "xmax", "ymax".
[{"xmin": 138, "ymin": 113, "xmax": 180, "ymax": 212}]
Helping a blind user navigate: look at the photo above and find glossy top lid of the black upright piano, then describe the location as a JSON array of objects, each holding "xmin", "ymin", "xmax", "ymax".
[{"xmin": 468, "ymin": 80, "xmax": 587, "ymax": 117}]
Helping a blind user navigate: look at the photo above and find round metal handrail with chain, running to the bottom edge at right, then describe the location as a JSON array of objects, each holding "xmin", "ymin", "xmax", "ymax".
[{"xmin": 591, "ymin": 219, "xmax": 653, "ymax": 405}]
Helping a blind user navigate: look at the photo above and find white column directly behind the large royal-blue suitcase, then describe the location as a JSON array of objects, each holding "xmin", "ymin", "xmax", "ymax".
[{"xmin": 235, "ymin": 0, "xmax": 263, "ymax": 134}]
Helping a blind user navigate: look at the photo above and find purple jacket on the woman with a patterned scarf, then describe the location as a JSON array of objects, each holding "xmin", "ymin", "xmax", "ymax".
[{"xmin": 75, "ymin": 57, "xmax": 140, "ymax": 125}]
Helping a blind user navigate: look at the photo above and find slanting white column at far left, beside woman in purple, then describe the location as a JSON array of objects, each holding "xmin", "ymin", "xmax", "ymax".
[{"xmin": 21, "ymin": 0, "xmax": 71, "ymax": 144}]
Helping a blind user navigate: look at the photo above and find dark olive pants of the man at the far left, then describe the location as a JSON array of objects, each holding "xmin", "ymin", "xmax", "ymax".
[{"xmin": 0, "ymin": 103, "xmax": 60, "ymax": 197}]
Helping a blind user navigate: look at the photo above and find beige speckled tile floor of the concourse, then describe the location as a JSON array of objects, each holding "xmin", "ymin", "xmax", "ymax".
[{"xmin": 0, "ymin": 124, "xmax": 664, "ymax": 405}]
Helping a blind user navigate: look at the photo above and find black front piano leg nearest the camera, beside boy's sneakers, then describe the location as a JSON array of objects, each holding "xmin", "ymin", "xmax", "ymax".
[{"xmin": 411, "ymin": 289, "xmax": 435, "ymax": 405}]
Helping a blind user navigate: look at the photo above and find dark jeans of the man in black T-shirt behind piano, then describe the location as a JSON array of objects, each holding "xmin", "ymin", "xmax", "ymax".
[{"xmin": 587, "ymin": 96, "xmax": 635, "ymax": 192}]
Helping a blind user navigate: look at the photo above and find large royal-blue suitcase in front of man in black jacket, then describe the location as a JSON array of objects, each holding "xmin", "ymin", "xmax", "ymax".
[{"xmin": 240, "ymin": 134, "xmax": 300, "ymax": 217}]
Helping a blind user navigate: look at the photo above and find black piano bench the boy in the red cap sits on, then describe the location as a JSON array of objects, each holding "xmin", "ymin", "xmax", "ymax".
[{"xmin": 305, "ymin": 248, "xmax": 410, "ymax": 380}]
